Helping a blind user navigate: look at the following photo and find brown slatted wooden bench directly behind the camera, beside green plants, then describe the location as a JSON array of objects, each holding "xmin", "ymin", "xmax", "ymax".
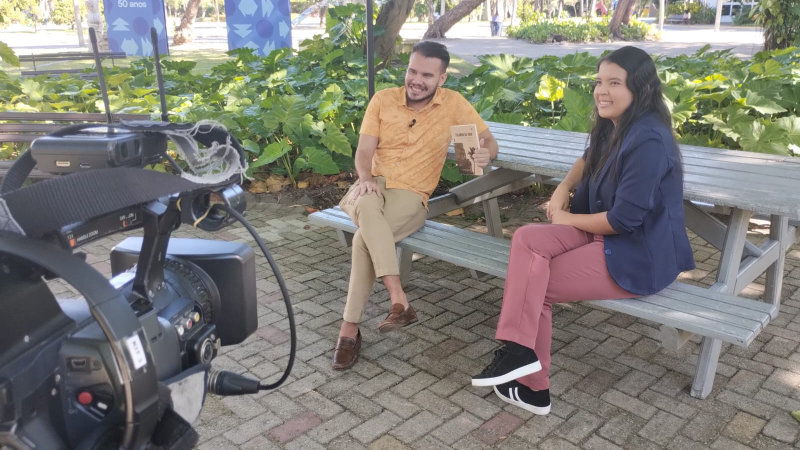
[{"xmin": 0, "ymin": 111, "xmax": 150, "ymax": 178}]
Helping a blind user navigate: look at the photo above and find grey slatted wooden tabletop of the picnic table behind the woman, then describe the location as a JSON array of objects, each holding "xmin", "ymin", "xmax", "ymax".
[{"xmin": 489, "ymin": 123, "xmax": 800, "ymax": 218}]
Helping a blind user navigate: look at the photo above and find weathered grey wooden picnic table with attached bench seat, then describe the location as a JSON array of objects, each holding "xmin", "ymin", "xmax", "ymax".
[{"xmin": 309, "ymin": 119, "xmax": 800, "ymax": 398}]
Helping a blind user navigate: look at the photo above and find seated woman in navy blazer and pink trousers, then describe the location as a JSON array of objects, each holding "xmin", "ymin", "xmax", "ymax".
[{"xmin": 472, "ymin": 47, "xmax": 694, "ymax": 414}]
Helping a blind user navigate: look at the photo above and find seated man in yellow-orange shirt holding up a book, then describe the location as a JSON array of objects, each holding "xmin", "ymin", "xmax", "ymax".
[{"xmin": 333, "ymin": 41, "xmax": 497, "ymax": 370}]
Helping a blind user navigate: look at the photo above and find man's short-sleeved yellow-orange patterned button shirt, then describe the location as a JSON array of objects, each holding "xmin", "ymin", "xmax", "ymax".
[{"xmin": 361, "ymin": 87, "xmax": 489, "ymax": 206}]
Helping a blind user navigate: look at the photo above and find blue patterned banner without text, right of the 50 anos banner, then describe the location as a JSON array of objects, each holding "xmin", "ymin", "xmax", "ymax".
[{"xmin": 225, "ymin": 0, "xmax": 292, "ymax": 56}]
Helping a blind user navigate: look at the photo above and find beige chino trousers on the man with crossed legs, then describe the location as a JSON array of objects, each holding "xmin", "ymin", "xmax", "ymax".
[{"xmin": 339, "ymin": 177, "xmax": 427, "ymax": 323}]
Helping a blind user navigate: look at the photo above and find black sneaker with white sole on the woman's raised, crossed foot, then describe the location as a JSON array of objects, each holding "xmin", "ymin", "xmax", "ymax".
[{"xmin": 472, "ymin": 341, "xmax": 542, "ymax": 386}]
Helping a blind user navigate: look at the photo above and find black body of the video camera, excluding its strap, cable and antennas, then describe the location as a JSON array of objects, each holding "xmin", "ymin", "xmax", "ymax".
[{"xmin": 0, "ymin": 120, "xmax": 258, "ymax": 450}]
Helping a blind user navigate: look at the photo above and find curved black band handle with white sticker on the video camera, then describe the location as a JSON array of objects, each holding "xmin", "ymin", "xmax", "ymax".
[{"xmin": 0, "ymin": 231, "xmax": 159, "ymax": 450}]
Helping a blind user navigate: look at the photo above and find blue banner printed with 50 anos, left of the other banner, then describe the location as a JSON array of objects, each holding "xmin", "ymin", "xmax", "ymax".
[{"xmin": 103, "ymin": 0, "xmax": 169, "ymax": 56}]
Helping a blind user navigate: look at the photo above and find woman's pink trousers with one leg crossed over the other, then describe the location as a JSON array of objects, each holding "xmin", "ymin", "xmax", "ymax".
[{"xmin": 495, "ymin": 224, "xmax": 636, "ymax": 391}]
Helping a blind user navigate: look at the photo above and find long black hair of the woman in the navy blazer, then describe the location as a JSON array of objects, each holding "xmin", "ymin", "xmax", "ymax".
[{"xmin": 583, "ymin": 46, "xmax": 680, "ymax": 180}]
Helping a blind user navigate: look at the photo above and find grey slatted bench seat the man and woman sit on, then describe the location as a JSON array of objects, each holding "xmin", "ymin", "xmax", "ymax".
[{"xmin": 308, "ymin": 207, "xmax": 778, "ymax": 390}]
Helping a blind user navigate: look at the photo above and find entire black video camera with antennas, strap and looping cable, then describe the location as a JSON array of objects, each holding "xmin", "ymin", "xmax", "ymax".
[{"xmin": 0, "ymin": 30, "xmax": 296, "ymax": 450}]
